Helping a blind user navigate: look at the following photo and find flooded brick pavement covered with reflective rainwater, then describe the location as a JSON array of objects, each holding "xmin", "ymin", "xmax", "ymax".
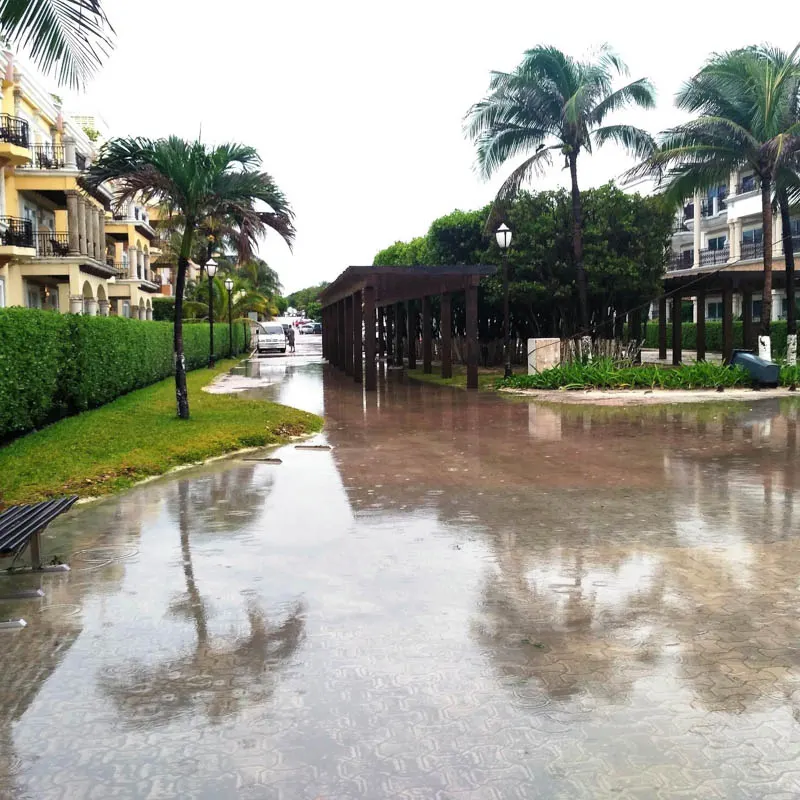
[{"xmin": 0, "ymin": 337, "xmax": 800, "ymax": 800}]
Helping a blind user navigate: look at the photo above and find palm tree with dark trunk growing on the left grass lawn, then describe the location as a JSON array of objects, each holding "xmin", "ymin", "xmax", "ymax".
[{"xmin": 86, "ymin": 136, "xmax": 294, "ymax": 419}]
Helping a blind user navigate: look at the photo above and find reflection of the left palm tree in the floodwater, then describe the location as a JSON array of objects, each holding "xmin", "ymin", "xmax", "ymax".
[{"xmin": 101, "ymin": 478, "xmax": 305, "ymax": 724}]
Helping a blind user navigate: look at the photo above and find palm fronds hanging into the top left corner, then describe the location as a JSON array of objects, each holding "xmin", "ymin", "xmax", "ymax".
[{"xmin": 0, "ymin": 0, "xmax": 114, "ymax": 89}]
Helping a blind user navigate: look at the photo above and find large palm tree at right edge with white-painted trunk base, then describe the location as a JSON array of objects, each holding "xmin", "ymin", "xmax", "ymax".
[{"xmin": 647, "ymin": 45, "xmax": 800, "ymax": 359}]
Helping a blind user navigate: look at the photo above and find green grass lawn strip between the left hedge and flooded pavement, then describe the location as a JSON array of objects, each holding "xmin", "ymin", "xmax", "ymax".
[{"xmin": 0, "ymin": 361, "xmax": 322, "ymax": 506}]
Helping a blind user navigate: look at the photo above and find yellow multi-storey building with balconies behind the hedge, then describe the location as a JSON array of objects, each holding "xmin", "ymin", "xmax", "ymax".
[{"xmin": 0, "ymin": 51, "xmax": 159, "ymax": 319}]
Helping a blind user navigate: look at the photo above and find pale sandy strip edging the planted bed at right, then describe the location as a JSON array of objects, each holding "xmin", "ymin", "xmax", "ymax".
[{"xmin": 498, "ymin": 389, "xmax": 800, "ymax": 406}]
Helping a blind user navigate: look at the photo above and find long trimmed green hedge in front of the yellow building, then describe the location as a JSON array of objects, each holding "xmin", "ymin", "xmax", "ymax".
[{"xmin": 0, "ymin": 308, "xmax": 250, "ymax": 440}]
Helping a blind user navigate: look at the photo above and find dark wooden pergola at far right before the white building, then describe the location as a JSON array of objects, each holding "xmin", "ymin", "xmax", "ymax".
[{"xmin": 658, "ymin": 267, "xmax": 786, "ymax": 364}]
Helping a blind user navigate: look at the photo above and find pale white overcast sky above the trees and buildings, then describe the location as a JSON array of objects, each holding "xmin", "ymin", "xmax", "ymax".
[{"xmin": 61, "ymin": 0, "xmax": 800, "ymax": 292}]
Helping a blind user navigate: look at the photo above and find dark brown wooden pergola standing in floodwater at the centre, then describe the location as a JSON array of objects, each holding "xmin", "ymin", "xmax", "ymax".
[{"xmin": 320, "ymin": 264, "xmax": 497, "ymax": 391}]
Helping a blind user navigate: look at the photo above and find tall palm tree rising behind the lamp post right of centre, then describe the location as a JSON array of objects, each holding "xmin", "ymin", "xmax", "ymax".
[{"xmin": 465, "ymin": 45, "xmax": 655, "ymax": 334}]
